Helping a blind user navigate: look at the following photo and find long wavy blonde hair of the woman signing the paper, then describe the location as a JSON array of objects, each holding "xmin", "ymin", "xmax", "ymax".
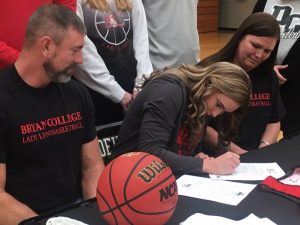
[{"xmin": 150, "ymin": 62, "xmax": 251, "ymax": 149}]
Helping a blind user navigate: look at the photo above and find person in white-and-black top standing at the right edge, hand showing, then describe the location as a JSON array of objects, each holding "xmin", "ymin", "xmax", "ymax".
[{"xmin": 254, "ymin": 0, "xmax": 300, "ymax": 137}]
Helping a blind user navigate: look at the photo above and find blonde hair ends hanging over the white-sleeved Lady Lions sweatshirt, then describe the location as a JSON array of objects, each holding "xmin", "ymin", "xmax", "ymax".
[{"xmin": 86, "ymin": 0, "xmax": 132, "ymax": 11}]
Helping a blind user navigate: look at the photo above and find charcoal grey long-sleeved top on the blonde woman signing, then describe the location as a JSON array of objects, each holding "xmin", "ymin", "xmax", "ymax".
[{"xmin": 112, "ymin": 77, "xmax": 203, "ymax": 176}]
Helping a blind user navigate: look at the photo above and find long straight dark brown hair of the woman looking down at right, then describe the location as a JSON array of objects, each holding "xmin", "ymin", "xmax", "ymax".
[{"xmin": 198, "ymin": 12, "xmax": 280, "ymax": 74}]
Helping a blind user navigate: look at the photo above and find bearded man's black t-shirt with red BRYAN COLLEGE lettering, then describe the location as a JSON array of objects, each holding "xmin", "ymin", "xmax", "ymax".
[{"xmin": 0, "ymin": 66, "xmax": 96, "ymax": 213}]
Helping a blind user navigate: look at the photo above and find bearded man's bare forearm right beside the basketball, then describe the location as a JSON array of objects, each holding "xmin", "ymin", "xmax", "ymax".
[{"xmin": 81, "ymin": 138, "xmax": 105, "ymax": 199}]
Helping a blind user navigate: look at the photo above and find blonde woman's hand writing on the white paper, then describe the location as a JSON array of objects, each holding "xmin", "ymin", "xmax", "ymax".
[{"xmin": 202, "ymin": 152, "xmax": 240, "ymax": 175}]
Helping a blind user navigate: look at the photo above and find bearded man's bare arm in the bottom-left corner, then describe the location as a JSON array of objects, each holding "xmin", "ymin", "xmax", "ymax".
[{"xmin": 0, "ymin": 163, "xmax": 37, "ymax": 225}]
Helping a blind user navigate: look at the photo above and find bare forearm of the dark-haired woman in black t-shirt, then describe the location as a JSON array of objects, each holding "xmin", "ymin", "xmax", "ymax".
[{"xmin": 259, "ymin": 122, "xmax": 280, "ymax": 148}]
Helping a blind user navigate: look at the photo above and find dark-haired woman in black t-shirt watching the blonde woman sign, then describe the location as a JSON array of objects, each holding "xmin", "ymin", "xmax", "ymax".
[{"xmin": 198, "ymin": 13, "xmax": 285, "ymax": 154}]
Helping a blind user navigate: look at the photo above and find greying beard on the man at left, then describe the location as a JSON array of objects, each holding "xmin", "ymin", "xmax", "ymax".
[{"xmin": 43, "ymin": 61, "xmax": 76, "ymax": 83}]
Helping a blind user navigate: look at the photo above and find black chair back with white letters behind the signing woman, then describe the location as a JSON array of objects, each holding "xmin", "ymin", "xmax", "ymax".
[{"xmin": 96, "ymin": 121, "xmax": 123, "ymax": 165}]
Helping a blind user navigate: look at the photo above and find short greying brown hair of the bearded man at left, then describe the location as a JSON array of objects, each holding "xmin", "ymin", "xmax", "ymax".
[{"xmin": 25, "ymin": 4, "xmax": 86, "ymax": 46}]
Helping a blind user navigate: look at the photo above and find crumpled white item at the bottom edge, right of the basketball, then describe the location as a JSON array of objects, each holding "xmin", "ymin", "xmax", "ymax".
[{"xmin": 180, "ymin": 213, "xmax": 276, "ymax": 225}]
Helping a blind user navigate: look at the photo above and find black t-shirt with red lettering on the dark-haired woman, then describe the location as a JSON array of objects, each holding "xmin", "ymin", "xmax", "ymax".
[{"xmin": 233, "ymin": 70, "xmax": 285, "ymax": 150}]
